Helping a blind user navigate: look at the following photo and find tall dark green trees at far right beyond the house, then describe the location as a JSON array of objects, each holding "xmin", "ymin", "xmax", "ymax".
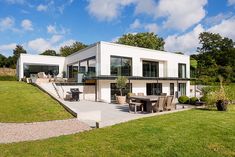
[{"xmin": 194, "ymin": 32, "xmax": 235, "ymax": 82}]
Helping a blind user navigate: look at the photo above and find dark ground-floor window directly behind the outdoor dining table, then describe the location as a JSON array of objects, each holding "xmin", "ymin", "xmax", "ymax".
[{"xmin": 146, "ymin": 83, "xmax": 162, "ymax": 95}]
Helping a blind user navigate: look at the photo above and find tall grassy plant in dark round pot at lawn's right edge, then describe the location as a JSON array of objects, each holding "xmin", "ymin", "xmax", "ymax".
[{"xmin": 216, "ymin": 76, "xmax": 228, "ymax": 111}]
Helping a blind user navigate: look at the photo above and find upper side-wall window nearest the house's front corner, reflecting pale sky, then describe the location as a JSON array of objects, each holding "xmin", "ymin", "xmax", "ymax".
[{"xmin": 79, "ymin": 57, "xmax": 96, "ymax": 76}]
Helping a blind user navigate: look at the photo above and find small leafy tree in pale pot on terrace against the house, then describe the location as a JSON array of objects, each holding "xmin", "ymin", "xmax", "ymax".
[{"xmin": 116, "ymin": 76, "xmax": 127, "ymax": 104}]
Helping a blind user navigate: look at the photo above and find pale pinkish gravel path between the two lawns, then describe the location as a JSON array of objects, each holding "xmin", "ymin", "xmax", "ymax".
[{"xmin": 0, "ymin": 118, "xmax": 91, "ymax": 143}]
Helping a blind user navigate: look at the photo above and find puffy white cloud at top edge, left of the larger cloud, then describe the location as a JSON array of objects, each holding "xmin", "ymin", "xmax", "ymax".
[{"xmin": 87, "ymin": 0, "xmax": 135, "ymax": 21}]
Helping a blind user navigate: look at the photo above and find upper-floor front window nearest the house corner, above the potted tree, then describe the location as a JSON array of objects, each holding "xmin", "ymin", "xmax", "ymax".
[{"xmin": 111, "ymin": 56, "xmax": 132, "ymax": 76}]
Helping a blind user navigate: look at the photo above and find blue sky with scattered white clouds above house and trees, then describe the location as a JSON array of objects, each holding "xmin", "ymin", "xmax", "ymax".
[{"xmin": 0, "ymin": 0, "xmax": 235, "ymax": 56}]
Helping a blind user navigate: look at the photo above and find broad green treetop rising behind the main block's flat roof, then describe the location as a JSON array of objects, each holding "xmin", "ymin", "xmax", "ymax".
[{"xmin": 116, "ymin": 32, "xmax": 165, "ymax": 50}]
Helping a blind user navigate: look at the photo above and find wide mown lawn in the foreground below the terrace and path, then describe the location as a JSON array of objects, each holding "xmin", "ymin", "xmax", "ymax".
[{"xmin": 0, "ymin": 105, "xmax": 235, "ymax": 157}]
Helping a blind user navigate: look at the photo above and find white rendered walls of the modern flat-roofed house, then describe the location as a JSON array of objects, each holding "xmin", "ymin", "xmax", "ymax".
[{"xmin": 18, "ymin": 42, "xmax": 190, "ymax": 102}]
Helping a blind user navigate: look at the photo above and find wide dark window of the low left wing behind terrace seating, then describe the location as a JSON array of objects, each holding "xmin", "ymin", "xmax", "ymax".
[{"xmin": 24, "ymin": 64, "xmax": 59, "ymax": 77}]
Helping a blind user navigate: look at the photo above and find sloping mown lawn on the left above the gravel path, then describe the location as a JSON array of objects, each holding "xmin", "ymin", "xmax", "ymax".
[{"xmin": 0, "ymin": 81, "xmax": 72, "ymax": 122}]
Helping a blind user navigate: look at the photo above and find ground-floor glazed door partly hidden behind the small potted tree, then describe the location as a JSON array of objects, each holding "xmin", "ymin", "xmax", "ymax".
[{"xmin": 110, "ymin": 83, "xmax": 132, "ymax": 102}]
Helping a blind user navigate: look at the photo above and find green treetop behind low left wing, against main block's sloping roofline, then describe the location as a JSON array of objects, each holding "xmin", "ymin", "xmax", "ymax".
[{"xmin": 60, "ymin": 41, "xmax": 87, "ymax": 57}]
